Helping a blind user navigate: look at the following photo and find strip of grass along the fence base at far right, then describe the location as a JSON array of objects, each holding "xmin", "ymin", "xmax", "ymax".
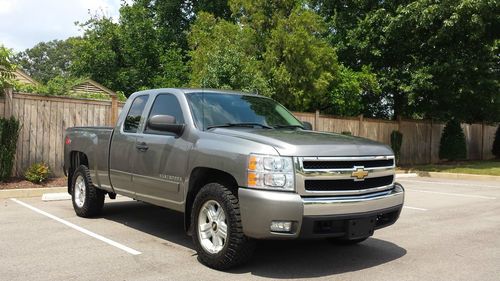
[{"xmin": 402, "ymin": 160, "xmax": 500, "ymax": 176}]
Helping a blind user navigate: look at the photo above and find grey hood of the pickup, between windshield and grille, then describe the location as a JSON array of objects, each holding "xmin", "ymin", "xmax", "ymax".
[{"xmin": 212, "ymin": 128, "xmax": 394, "ymax": 157}]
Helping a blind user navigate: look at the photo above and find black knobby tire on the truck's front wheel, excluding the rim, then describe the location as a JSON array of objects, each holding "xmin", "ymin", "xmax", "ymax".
[{"xmin": 191, "ymin": 183, "xmax": 256, "ymax": 270}]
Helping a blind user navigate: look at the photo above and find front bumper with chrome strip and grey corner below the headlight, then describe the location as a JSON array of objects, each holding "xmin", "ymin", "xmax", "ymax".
[{"xmin": 238, "ymin": 183, "xmax": 404, "ymax": 239}]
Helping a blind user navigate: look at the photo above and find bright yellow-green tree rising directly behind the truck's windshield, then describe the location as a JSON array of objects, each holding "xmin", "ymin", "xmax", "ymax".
[{"xmin": 264, "ymin": 7, "xmax": 339, "ymax": 111}]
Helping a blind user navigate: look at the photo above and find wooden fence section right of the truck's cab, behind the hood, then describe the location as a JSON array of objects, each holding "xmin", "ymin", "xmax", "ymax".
[{"xmin": 294, "ymin": 112, "xmax": 497, "ymax": 165}]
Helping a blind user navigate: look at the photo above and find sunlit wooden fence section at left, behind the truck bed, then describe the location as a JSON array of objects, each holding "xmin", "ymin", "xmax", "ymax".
[{"xmin": 0, "ymin": 93, "xmax": 123, "ymax": 176}]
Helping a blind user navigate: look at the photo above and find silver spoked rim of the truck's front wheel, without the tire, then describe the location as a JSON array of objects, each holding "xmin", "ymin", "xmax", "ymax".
[{"xmin": 198, "ymin": 200, "xmax": 227, "ymax": 254}]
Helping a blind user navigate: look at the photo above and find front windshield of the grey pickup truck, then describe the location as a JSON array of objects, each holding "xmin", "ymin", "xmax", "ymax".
[{"xmin": 186, "ymin": 93, "xmax": 302, "ymax": 130}]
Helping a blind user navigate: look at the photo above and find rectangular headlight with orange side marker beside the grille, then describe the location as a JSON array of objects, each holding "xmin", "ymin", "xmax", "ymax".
[{"xmin": 247, "ymin": 154, "xmax": 295, "ymax": 191}]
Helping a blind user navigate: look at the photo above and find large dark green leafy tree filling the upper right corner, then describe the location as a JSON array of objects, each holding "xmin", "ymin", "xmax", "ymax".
[{"xmin": 311, "ymin": 0, "xmax": 500, "ymax": 122}]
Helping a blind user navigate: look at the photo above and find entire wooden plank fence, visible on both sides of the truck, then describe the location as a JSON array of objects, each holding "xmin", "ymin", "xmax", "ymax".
[{"xmin": 0, "ymin": 93, "xmax": 496, "ymax": 176}]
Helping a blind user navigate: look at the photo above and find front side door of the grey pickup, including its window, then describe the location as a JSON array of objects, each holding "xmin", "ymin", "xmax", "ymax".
[{"xmin": 133, "ymin": 93, "xmax": 190, "ymax": 209}]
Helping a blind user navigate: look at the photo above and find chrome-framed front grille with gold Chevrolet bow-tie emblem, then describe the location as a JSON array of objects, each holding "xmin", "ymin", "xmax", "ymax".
[{"xmin": 295, "ymin": 156, "xmax": 395, "ymax": 196}]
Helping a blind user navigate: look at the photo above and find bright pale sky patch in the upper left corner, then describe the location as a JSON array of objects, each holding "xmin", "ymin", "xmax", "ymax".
[{"xmin": 0, "ymin": 0, "xmax": 121, "ymax": 52}]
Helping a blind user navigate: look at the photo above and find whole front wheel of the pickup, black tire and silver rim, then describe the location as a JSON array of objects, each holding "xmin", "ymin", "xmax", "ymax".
[{"xmin": 191, "ymin": 183, "xmax": 255, "ymax": 270}]
